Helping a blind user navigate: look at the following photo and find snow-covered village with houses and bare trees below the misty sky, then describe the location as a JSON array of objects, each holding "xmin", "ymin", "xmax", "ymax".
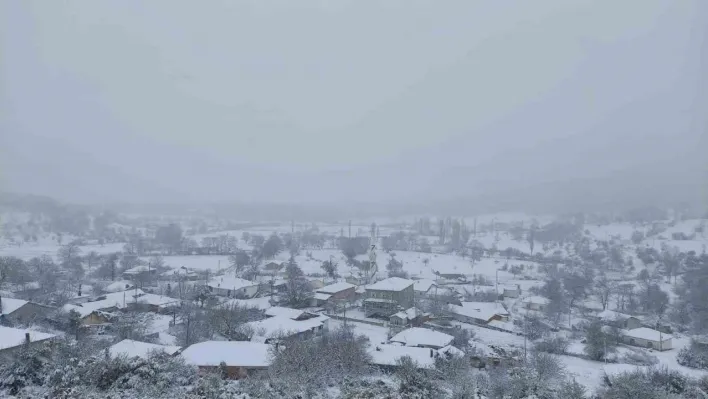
[{"xmin": 0, "ymin": 203, "xmax": 708, "ymax": 398}]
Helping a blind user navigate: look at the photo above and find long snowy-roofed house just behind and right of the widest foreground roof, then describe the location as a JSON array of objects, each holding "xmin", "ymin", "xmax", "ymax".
[{"xmin": 245, "ymin": 316, "xmax": 329, "ymax": 343}]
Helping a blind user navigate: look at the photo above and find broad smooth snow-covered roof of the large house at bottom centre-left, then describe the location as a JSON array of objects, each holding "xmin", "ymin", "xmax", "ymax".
[{"xmin": 182, "ymin": 341, "xmax": 271, "ymax": 367}]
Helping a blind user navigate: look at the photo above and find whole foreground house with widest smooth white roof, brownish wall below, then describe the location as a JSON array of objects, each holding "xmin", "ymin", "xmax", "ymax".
[{"xmin": 182, "ymin": 341, "xmax": 271, "ymax": 379}]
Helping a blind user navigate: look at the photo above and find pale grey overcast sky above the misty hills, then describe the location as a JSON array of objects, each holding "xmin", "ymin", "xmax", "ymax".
[{"xmin": 0, "ymin": 0, "xmax": 708, "ymax": 206}]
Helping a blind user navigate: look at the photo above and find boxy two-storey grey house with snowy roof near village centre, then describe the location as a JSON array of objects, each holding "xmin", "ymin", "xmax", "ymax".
[{"xmin": 364, "ymin": 277, "xmax": 415, "ymax": 318}]
